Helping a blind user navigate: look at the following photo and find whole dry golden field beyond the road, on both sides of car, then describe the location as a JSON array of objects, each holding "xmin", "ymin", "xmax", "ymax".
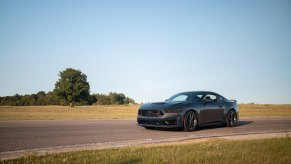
[{"xmin": 0, "ymin": 104, "xmax": 291, "ymax": 121}]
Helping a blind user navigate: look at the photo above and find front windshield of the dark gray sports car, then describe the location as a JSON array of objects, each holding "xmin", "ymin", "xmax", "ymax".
[{"xmin": 167, "ymin": 93, "xmax": 203, "ymax": 102}]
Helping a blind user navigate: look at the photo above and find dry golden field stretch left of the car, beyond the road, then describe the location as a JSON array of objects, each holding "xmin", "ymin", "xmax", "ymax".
[{"xmin": 0, "ymin": 105, "xmax": 139, "ymax": 121}]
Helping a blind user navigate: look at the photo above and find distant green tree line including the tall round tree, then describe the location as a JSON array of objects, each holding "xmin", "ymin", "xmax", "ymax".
[{"xmin": 0, "ymin": 68, "xmax": 135, "ymax": 106}]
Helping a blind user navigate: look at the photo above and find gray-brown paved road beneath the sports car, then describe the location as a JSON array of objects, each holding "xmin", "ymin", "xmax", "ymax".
[{"xmin": 0, "ymin": 117, "xmax": 291, "ymax": 153}]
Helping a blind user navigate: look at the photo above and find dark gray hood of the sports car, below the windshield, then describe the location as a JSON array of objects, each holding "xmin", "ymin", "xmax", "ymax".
[{"xmin": 139, "ymin": 101, "xmax": 189, "ymax": 110}]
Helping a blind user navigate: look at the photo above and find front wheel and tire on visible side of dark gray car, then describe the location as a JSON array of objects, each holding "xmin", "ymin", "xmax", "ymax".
[{"xmin": 183, "ymin": 111, "xmax": 198, "ymax": 132}]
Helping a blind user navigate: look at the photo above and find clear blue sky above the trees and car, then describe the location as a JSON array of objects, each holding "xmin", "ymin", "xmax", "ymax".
[{"xmin": 0, "ymin": 0, "xmax": 291, "ymax": 103}]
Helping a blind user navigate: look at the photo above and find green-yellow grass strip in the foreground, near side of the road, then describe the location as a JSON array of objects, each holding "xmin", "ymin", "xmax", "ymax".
[{"xmin": 1, "ymin": 137, "xmax": 291, "ymax": 164}]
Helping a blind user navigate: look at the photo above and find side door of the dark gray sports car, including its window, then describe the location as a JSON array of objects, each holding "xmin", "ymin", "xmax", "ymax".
[{"xmin": 200, "ymin": 94, "xmax": 224, "ymax": 123}]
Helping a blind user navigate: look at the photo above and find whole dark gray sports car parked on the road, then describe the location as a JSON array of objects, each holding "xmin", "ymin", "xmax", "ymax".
[{"xmin": 137, "ymin": 91, "xmax": 239, "ymax": 131}]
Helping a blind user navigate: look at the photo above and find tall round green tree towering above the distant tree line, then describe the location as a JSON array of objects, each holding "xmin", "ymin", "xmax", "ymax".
[{"xmin": 54, "ymin": 68, "xmax": 90, "ymax": 106}]
